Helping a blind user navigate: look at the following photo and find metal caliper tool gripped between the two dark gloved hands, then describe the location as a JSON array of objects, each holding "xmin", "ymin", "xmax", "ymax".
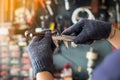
[{"xmin": 25, "ymin": 31, "xmax": 75, "ymax": 48}]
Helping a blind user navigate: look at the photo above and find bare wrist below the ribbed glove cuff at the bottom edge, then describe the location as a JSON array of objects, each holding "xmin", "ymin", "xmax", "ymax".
[{"xmin": 36, "ymin": 71, "xmax": 54, "ymax": 80}]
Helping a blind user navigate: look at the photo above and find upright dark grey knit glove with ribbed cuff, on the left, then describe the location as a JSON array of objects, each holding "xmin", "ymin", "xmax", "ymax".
[{"xmin": 28, "ymin": 31, "xmax": 55, "ymax": 75}]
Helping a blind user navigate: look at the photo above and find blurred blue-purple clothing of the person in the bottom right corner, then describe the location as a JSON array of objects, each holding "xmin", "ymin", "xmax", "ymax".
[{"xmin": 92, "ymin": 50, "xmax": 120, "ymax": 80}]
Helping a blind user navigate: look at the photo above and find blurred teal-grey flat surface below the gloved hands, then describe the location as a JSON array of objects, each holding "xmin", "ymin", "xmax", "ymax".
[{"xmin": 53, "ymin": 40, "xmax": 112, "ymax": 80}]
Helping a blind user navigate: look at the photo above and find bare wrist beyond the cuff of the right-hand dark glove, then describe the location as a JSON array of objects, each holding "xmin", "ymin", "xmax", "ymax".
[{"xmin": 108, "ymin": 27, "xmax": 120, "ymax": 49}]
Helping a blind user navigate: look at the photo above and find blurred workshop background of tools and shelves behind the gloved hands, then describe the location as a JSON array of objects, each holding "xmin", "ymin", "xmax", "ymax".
[{"xmin": 0, "ymin": 0, "xmax": 120, "ymax": 80}]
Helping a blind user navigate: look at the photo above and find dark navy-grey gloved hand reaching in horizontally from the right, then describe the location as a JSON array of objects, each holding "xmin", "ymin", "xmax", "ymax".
[{"xmin": 62, "ymin": 19, "xmax": 111, "ymax": 44}]
